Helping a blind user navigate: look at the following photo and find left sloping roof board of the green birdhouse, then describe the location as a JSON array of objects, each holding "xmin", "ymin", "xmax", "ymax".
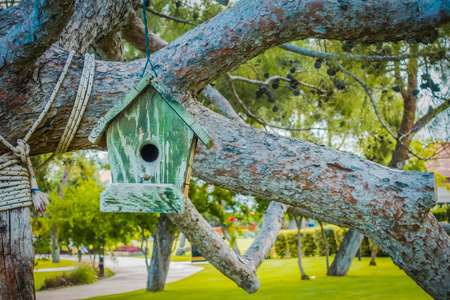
[{"xmin": 89, "ymin": 73, "xmax": 152, "ymax": 144}]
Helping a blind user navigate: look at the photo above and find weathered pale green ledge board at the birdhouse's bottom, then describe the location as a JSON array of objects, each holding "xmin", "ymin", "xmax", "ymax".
[{"xmin": 100, "ymin": 183, "xmax": 184, "ymax": 213}]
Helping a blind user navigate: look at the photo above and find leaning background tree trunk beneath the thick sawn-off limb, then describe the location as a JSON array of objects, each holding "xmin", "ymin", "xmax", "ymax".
[{"xmin": 327, "ymin": 228, "xmax": 364, "ymax": 276}]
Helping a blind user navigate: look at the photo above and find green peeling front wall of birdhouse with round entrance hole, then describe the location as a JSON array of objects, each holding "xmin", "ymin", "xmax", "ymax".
[{"xmin": 107, "ymin": 87, "xmax": 194, "ymax": 202}]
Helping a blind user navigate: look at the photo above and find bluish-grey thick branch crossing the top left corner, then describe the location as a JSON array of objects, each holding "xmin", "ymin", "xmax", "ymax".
[{"xmin": 0, "ymin": 0, "xmax": 75, "ymax": 74}]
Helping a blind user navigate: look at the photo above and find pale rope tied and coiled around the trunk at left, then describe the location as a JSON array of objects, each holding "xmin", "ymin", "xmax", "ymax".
[{"xmin": 0, "ymin": 51, "xmax": 95, "ymax": 214}]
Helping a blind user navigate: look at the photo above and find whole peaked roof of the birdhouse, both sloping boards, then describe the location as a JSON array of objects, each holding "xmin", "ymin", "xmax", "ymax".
[{"xmin": 89, "ymin": 73, "xmax": 213, "ymax": 149}]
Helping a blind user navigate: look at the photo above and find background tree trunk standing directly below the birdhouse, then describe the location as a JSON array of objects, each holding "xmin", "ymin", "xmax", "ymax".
[{"xmin": 147, "ymin": 214, "xmax": 175, "ymax": 292}]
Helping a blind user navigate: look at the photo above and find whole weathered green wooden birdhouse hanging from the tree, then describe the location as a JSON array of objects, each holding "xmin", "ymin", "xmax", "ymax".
[{"xmin": 89, "ymin": 74, "xmax": 213, "ymax": 213}]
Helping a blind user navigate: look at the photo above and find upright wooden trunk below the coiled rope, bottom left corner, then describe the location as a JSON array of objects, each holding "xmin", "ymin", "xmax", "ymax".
[{"xmin": 0, "ymin": 207, "xmax": 36, "ymax": 300}]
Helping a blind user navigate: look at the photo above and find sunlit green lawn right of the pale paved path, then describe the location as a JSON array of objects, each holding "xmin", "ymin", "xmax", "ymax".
[{"xmin": 87, "ymin": 257, "xmax": 431, "ymax": 300}]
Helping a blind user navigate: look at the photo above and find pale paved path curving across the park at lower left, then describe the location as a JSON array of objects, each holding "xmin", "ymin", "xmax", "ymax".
[{"xmin": 36, "ymin": 256, "xmax": 203, "ymax": 300}]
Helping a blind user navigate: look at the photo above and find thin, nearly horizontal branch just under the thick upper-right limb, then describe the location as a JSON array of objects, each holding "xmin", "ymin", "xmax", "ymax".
[{"xmin": 278, "ymin": 43, "xmax": 448, "ymax": 61}]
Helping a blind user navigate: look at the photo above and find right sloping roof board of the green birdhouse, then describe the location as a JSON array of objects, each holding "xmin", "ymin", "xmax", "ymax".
[{"xmin": 151, "ymin": 78, "xmax": 214, "ymax": 149}]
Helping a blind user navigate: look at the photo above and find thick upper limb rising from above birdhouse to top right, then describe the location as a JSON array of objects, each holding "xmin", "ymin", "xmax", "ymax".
[{"xmin": 137, "ymin": 0, "xmax": 450, "ymax": 94}]
